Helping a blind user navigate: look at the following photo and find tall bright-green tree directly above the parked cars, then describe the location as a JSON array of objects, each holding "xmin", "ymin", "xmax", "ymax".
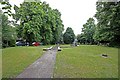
[{"xmin": 13, "ymin": 2, "xmax": 41, "ymax": 45}]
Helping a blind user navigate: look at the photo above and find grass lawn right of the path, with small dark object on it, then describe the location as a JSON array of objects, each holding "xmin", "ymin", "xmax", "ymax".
[{"xmin": 54, "ymin": 45, "xmax": 118, "ymax": 78}]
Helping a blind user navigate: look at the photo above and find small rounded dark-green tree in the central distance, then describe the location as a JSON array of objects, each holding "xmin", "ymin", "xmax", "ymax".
[{"xmin": 63, "ymin": 27, "xmax": 75, "ymax": 44}]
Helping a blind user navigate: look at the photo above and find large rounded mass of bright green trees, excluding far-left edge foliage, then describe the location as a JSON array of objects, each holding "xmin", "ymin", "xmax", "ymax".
[{"xmin": 13, "ymin": 2, "xmax": 64, "ymax": 44}]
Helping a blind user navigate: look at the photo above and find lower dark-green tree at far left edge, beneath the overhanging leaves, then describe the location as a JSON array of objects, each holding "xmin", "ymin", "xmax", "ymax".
[{"xmin": 2, "ymin": 13, "xmax": 16, "ymax": 47}]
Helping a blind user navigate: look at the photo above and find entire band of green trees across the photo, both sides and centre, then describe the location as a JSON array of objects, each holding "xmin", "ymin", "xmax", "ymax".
[{"xmin": 0, "ymin": 0, "xmax": 120, "ymax": 46}]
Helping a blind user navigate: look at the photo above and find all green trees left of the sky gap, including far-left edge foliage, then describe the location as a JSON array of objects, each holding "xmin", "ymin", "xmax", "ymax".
[{"xmin": 0, "ymin": 1, "xmax": 64, "ymax": 47}]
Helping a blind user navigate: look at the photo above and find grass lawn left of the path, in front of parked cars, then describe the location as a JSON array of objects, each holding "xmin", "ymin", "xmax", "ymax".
[{"xmin": 2, "ymin": 45, "xmax": 50, "ymax": 78}]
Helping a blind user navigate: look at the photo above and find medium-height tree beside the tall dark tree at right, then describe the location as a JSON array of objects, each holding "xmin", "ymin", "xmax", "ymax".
[{"xmin": 82, "ymin": 18, "xmax": 95, "ymax": 44}]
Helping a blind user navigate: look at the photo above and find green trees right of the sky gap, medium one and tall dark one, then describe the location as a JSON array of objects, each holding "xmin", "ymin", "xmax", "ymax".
[{"xmin": 77, "ymin": 2, "xmax": 120, "ymax": 46}]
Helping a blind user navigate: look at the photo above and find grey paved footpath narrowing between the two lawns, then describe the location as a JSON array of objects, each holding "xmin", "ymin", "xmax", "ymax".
[{"xmin": 17, "ymin": 47, "xmax": 57, "ymax": 78}]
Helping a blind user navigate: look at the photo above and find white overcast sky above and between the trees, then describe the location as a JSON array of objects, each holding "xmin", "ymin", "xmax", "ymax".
[{"xmin": 9, "ymin": 0, "xmax": 97, "ymax": 35}]
